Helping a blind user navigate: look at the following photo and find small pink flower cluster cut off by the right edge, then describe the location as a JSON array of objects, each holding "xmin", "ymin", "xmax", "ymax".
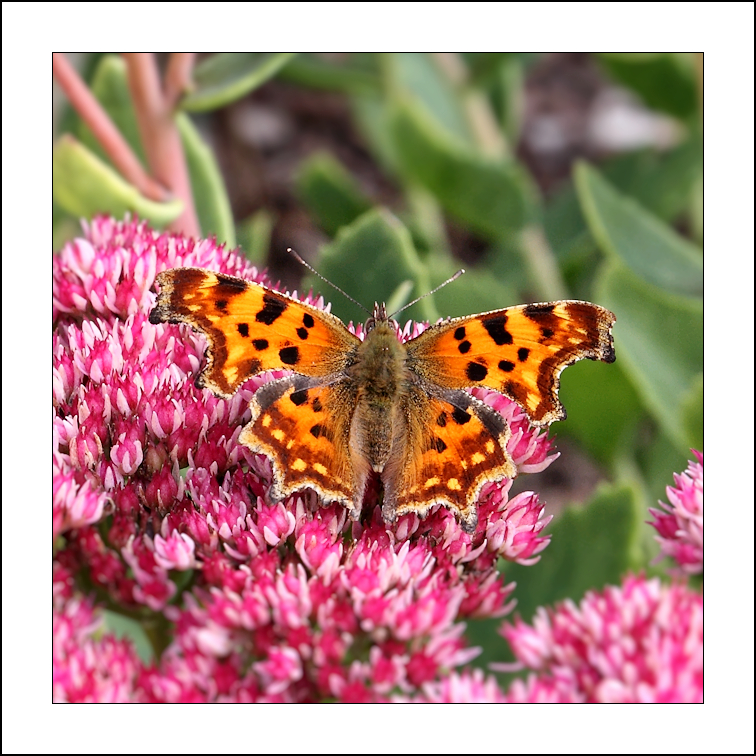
[{"xmin": 650, "ymin": 449, "xmax": 703, "ymax": 575}]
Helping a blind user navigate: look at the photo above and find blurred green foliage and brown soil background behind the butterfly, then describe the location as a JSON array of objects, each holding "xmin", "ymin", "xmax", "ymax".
[{"xmin": 53, "ymin": 53, "xmax": 703, "ymax": 664}]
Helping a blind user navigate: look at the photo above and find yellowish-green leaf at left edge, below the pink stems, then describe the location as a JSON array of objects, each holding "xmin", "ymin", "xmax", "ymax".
[{"xmin": 53, "ymin": 134, "xmax": 183, "ymax": 227}]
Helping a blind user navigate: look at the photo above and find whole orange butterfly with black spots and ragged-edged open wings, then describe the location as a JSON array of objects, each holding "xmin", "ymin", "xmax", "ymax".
[{"xmin": 150, "ymin": 268, "xmax": 615, "ymax": 533}]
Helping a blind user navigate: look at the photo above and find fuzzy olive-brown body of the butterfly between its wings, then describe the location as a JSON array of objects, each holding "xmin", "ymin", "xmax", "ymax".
[{"xmin": 348, "ymin": 318, "xmax": 409, "ymax": 472}]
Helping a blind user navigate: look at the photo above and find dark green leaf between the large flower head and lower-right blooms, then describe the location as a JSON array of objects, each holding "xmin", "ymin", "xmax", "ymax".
[{"xmin": 505, "ymin": 484, "xmax": 643, "ymax": 621}]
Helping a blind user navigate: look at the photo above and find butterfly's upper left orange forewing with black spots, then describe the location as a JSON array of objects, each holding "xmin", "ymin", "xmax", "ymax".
[{"xmin": 150, "ymin": 268, "xmax": 360, "ymax": 396}]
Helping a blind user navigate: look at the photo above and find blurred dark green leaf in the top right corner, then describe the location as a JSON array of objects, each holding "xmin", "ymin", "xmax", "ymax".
[{"xmin": 597, "ymin": 53, "xmax": 698, "ymax": 120}]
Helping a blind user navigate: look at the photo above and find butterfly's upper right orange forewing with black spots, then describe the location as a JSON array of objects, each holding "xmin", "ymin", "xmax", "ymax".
[{"xmin": 407, "ymin": 300, "xmax": 615, "ymax": 425}]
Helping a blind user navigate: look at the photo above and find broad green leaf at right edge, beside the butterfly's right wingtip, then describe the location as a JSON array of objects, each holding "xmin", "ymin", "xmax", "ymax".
[{"xmin": 596, "ymin": 262, "xmax": 703, "ymax": 451}]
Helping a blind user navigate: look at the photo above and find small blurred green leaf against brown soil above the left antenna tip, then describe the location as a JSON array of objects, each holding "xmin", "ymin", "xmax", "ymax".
[{"xmin": 297, "ymin": 152, "xmax": 371, "ymax": 236}]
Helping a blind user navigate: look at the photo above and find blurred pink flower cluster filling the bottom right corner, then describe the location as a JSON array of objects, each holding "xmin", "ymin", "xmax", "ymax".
[{"xmin": 502, "ymin": 576, "xmax": 703, "ymax": 703}]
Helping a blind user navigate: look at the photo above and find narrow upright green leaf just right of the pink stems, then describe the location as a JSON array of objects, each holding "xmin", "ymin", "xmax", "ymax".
[{"xmin": 175, "ymin": 113, "xmax": 236, "ymax": 247}]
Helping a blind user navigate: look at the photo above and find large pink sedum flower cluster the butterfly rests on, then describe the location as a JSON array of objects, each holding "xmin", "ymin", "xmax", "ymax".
[{"xmin": 53, "ymin": 218, "xmax": 555, "ymax": 701}]
